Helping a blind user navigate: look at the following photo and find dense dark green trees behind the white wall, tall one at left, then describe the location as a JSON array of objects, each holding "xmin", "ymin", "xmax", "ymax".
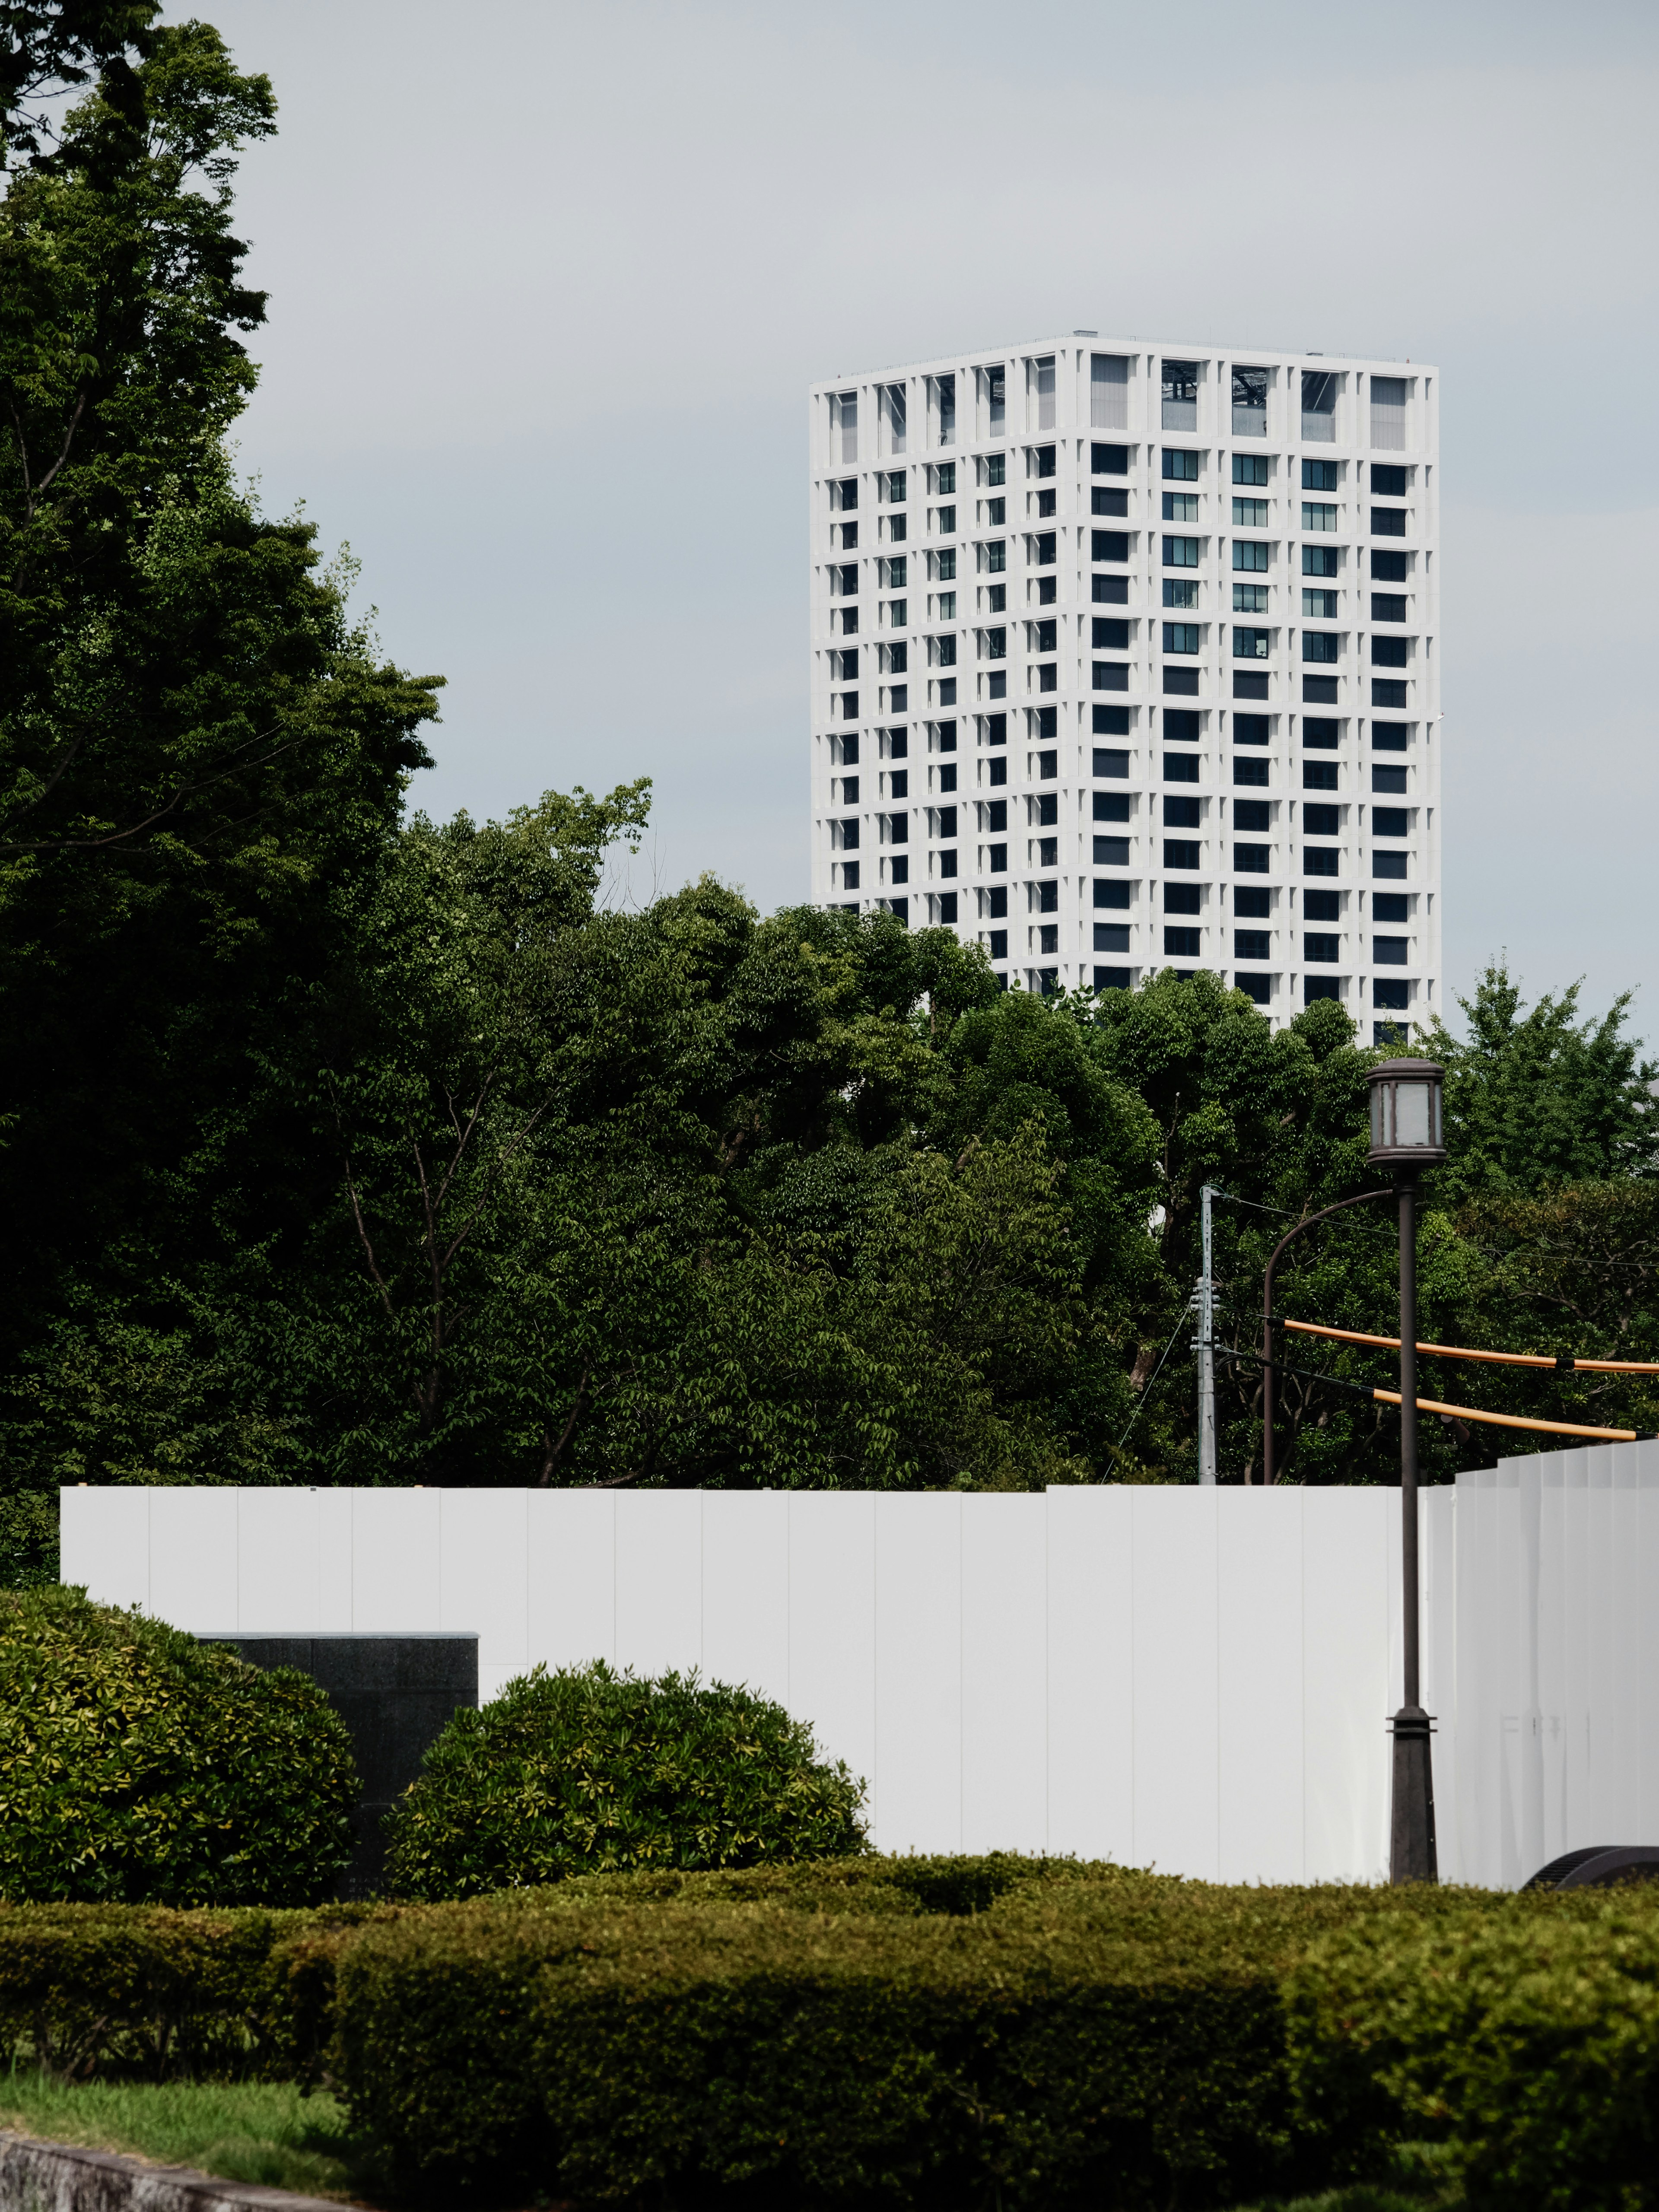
[{"xmin": 0, "ymin": 0, "xmax": 1659, "ymax": 1582}]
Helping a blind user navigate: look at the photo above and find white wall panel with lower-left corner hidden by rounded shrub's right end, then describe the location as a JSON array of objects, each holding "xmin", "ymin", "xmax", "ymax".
[{"xmin": 785, "ymin": 1491, "xmax": 876, "ymax": 1827}]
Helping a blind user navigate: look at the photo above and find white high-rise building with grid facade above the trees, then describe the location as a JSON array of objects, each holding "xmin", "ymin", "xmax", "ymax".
[{"xmin": 812, "ymin": 330, "xmax": 1440, "ymax": 1042}]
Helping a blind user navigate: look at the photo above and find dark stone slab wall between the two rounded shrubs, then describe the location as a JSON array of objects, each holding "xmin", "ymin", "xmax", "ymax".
[{"xmin": 201, "ymin": 1635, "xmax": 478, "ymax": 1898}]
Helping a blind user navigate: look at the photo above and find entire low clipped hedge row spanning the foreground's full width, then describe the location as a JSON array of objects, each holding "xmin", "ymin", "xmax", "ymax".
[{"xmin": 0, "ymin": 1858, "xmax": 1659, "ymax": 2212}]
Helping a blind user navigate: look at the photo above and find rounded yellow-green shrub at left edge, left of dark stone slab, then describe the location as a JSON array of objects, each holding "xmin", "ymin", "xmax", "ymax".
[{"xmin": 0, "ymin": 1588, "xmax": 358, "ymax": 1904}]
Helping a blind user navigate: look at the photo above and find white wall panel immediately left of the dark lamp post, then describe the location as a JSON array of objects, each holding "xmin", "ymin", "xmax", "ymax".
[{"xmin": 1303, "ymin": 1489, "xmax": 1400, "ymax": 1882}]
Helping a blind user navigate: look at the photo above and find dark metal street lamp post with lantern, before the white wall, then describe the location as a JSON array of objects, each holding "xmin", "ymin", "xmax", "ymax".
[{"xmin": 1369, "ymin": 1059, "xmax": 1446, "ymax": 1882}]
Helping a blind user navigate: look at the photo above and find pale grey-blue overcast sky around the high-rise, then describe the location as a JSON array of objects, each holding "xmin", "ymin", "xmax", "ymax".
[{"xmin": 172, "ymin": 0, "xmax": 1659, "ymax": 1039}]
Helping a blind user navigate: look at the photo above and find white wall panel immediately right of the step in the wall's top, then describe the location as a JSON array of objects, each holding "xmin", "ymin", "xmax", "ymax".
[{"xmin": 1049, "ymin": 1484, "xmax": 1135, "ymax": 1865}]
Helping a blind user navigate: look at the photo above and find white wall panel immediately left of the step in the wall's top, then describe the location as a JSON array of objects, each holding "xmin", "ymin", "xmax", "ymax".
[{"xmin": 960, "ymin": 1495, "xmax": 1049, "ymax": 1851}]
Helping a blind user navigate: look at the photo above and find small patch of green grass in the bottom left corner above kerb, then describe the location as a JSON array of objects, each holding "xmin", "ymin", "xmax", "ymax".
[{"xmin": 0, "ymin": 2068, "xmax": 381, "ymax": 2203}]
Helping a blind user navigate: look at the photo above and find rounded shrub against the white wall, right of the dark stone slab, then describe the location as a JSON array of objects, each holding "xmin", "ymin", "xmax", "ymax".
[{"xmin": 387, "ymin": 1659, "xmax": 865, "ymax": 1900}]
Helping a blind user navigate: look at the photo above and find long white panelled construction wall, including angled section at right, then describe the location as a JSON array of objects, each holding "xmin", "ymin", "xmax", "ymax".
[{"xmin": 62, "ymin": 1444, "xmax": 1659, "ymax": 1885}]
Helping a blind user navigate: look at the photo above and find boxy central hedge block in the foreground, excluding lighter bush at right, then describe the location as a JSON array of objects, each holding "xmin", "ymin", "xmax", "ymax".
[{"xmin": 321, "ymin": 1858, "xmax": 1484, "ymax": 2212}]
